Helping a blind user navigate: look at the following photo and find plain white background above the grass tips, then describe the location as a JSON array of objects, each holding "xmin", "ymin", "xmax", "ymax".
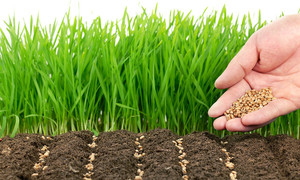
[{"xmin": 0, "ymin": 0, "xmax": 300, "ymax": 28}]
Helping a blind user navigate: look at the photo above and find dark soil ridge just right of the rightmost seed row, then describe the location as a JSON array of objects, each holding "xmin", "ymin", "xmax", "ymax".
[{"xmin": 225, "ymin": 134, "xmax": 286, "ymax": 179}]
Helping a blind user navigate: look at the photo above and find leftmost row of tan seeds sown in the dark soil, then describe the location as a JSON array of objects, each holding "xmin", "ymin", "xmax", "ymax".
[{"xmin": 32, "ymin": 136, "xmax": 52, "ymax": 176}]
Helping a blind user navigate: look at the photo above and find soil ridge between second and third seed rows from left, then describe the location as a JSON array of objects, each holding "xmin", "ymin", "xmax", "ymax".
[{"xmin": 92, "ymin": 130, "xmax": 138, "ymax": 179}]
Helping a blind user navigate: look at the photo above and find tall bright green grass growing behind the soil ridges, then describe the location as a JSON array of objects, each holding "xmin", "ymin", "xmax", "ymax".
[{"xmin": 0, "ymin": 8, "xmax": 300, "ymax": 138}]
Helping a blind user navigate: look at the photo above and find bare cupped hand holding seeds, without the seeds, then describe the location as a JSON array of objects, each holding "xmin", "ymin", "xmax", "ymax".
[{"xmin": 208, "ymin": 15, "xmax": 300, "ymax": 131}]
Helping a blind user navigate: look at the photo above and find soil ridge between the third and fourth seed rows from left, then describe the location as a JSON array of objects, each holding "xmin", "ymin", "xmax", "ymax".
[{"xmin": 142, "ymin": 129, "xmax": 182, "ymax": 180}]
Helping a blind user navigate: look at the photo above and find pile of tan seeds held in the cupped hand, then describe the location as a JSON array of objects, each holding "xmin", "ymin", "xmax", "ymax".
[{"xmin": 224, "ymin": 88, "xmax": 275, "ymax": 120}]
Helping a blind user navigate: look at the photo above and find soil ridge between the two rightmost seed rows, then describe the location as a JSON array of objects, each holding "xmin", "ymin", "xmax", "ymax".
[{"xmin": 183, "ymin": 132, "xmax": 231, "ymax": 179}]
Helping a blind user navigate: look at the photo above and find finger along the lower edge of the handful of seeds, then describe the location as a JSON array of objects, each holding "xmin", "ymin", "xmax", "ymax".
[{"xmin": 242, "ymin": 99, "xmax": 297, "ymax": 126}]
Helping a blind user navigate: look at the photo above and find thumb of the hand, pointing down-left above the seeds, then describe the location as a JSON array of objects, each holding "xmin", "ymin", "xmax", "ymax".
[{"xmin": 215, "ymin": 35, "xmax": 258, "ymax": 89}]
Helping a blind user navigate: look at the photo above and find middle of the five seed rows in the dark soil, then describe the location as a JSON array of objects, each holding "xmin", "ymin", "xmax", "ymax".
[{"xmin": 134, "ymin": 136, "xmax": 146, "ymax": 180}]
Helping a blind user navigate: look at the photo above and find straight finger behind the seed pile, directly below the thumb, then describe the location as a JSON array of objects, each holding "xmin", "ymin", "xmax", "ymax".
[{"xmin": 208, "ymin": 79, "xmax": 251, "ymax": 117}]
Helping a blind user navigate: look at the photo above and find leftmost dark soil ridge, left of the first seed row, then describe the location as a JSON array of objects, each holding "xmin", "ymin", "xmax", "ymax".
[{"xmin": 0, "ymin": 134, "xmax": 46, "ymax": 179}]
